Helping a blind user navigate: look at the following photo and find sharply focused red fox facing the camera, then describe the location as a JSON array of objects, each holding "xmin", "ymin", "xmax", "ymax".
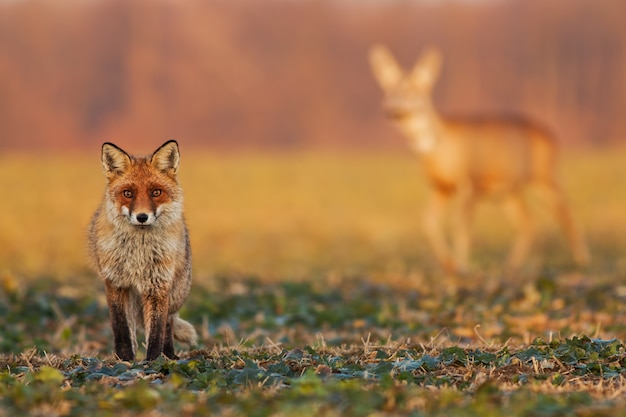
[{"xmin": 88, "ymin": 140, "xmax": 198, "ymax": 361}]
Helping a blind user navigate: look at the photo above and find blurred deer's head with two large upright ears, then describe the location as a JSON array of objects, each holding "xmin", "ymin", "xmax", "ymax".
[{"xmin": 370, "ymin": 45, "xmax": 441, "ymax": 120}]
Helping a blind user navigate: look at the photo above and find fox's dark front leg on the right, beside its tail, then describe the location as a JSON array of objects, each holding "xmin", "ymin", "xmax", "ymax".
[{"xmin": 143, "ymin": 291, "xmax": 168, "ymax": 361}]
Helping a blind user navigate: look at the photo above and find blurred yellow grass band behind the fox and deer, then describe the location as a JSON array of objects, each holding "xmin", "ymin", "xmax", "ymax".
[{"xmin": 0, "ymin": 146, "xmax": 626, "ymax": 281}]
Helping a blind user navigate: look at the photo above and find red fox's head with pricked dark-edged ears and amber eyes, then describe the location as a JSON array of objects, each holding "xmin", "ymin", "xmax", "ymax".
[{"xmin": 102, "ymin": 140, "xmax": 182, "ymax": 229}]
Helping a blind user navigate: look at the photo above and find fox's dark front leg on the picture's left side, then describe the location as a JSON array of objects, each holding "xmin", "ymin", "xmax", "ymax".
[{"xmin": 104, "ymin": 280, "xmax": 135, "ymax": 361}]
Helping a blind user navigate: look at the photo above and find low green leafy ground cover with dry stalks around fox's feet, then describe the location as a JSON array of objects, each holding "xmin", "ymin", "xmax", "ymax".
[{"xmin": 0, "ymin": 277, "xmax": 626, "ymax": 416}]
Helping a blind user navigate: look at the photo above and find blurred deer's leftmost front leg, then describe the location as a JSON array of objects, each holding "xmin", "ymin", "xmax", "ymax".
[{"xmin": 423, "ymin": 191, "xmax": 457, "ymax": 273}]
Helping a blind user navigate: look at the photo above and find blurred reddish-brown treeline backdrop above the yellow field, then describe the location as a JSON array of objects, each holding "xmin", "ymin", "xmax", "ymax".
[{"xmin": 0, "ymin": 0, "xmax": 626, "ymax": 151}]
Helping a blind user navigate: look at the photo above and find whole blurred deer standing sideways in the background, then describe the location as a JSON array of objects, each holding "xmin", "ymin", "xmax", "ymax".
[{"xmin": 369, "ymin": 44, "xmax": 590, "ymax": 274}]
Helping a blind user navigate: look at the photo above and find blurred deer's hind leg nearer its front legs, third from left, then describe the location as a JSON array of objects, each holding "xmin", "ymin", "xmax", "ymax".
[{"xmin": 503, "ymin": 193, "xmax": 534, "ymax": 268}]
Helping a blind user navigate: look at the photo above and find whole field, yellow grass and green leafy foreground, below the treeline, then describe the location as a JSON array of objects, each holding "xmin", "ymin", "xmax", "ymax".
[{"xmin": 0, "ymin": 147, "xmax": 626, "ymax": 416}]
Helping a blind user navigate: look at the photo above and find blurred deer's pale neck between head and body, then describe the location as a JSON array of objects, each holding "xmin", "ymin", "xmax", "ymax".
[{"xmin": 397, "ymin": 112, "xmax": 441, "ymax": 154}]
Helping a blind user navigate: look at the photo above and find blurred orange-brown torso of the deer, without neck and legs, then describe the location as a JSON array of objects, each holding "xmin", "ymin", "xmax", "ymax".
[{"xmin": 414, "ymin": 120, "xmax": 555, "ymax": 194}]
